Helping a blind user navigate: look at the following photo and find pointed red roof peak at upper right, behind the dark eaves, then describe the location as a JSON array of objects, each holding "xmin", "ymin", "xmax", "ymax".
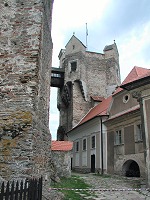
[{"xmin": 113, "ymin": 66, "xmax": 150, "ymax": 95}]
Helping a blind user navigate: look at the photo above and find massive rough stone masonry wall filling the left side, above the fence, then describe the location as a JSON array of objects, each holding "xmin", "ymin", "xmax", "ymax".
[{"xmin": 0, "ymin": 0, "xmax": 53, "ymax": 186}]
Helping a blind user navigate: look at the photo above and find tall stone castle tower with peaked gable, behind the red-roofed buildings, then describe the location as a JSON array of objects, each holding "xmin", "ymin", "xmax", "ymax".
[{"xmin": 57, "ymin": 35, "xmax": 120, "ymax": 140}]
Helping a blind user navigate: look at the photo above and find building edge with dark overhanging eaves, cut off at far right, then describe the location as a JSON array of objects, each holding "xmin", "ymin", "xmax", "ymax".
[{"xmin": 122, "ymin": 70, "xmax": 150, "ymax": 187}]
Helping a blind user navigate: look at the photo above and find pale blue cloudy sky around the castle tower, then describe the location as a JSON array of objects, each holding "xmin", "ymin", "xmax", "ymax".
[{"xmin": 49, "ymin": 0, "xmax": 150, "ymax": 140}]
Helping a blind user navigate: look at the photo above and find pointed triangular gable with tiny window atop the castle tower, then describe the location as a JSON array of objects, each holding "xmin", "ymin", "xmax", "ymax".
[{"xmin": 65, "ymin": 35, "xmax": 86, "ymax": 55}]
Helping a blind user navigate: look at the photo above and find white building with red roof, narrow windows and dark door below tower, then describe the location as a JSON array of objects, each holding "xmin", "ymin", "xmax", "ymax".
[{"xmin": 67, "ymin": 96, "xmax": 111, "ymax": 173}]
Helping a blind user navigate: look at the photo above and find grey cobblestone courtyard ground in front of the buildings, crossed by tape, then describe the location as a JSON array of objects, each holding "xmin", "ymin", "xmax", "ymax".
[{"xmin": 73, "ymin": 173, "xmax": 150, "ymax": 200}]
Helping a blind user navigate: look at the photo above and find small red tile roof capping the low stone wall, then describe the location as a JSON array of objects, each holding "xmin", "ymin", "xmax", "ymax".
[{"xmin": 51, "ymin": 141, "xmax": 73, "ymax": 151}]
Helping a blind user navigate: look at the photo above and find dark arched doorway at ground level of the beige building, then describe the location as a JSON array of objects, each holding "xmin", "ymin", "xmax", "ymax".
[{"xmin": 122, "ymin": 160, "xmax": 140, "ymax": 177}]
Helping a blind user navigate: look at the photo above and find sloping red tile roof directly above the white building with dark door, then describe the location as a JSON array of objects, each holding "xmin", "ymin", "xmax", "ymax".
[{"xmin": 77, "ymin": 96, "xmax": 112, "ymax": 126}]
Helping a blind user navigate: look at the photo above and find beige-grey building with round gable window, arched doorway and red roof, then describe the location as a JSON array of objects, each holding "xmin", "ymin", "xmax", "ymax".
[{"xmin": 105, "ymin": 67, "xmax": 149, "ymax": 176}]
